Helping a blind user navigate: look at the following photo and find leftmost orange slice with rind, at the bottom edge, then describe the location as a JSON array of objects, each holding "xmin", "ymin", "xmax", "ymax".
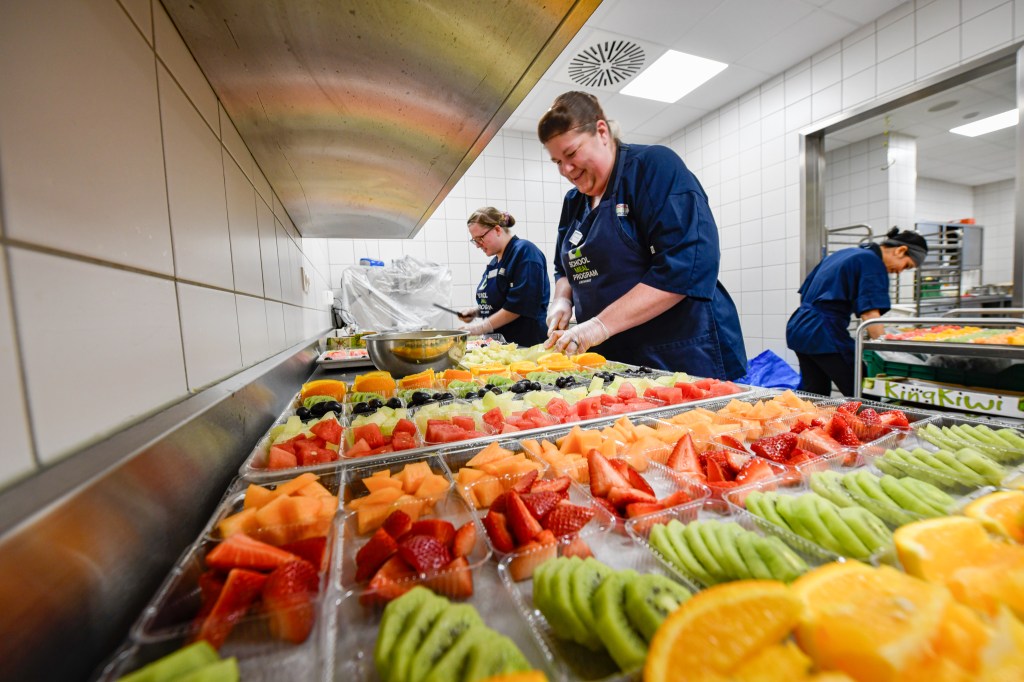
[{"xmin": 643, "ymin": 581, "xmax": 801, "ymax": 682}]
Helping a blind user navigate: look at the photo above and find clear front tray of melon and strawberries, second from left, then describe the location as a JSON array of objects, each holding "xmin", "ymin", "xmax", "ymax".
[{"xmin": 336, "ymin": 458, "xmax": 490, "ymax": 604}]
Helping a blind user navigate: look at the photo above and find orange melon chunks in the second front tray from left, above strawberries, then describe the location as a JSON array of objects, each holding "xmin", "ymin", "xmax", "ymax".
[{"xmin": 341, "ymin": 456, "xmax": 452, "ymax": 538}]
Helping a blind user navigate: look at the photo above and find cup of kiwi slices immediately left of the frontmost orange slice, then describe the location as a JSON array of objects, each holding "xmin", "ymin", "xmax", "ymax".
[{"xmin": 498, "ymin": 534, "xmax": 696, "ymax": 682}]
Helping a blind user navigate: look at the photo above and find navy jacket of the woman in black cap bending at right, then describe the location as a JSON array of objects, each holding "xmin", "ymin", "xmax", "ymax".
[{"xmin": 785, "ymin": 244, "xmax": 891, "ymax": 365}]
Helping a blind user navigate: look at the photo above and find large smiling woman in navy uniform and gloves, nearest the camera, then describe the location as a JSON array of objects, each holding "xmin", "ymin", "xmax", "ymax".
[{"xmin": 538, "ymin": 92, "xmax": 746, "ymax": 379}]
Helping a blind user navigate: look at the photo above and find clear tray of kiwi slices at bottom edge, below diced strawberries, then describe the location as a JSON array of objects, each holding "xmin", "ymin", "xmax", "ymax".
[{"xmin": 326, "ymin": 562, "xmax": 558, "ymax": 682}]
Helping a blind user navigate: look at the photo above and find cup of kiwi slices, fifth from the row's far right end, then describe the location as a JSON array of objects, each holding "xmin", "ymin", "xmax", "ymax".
[{"xmin": 626, "ymin": 500, "xmax": 831, "ymax": 587}]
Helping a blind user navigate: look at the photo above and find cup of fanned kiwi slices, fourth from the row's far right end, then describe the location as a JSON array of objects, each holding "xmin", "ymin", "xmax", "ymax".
[{"xmin": 725, "ymin": 472, "xmax": 895, "ymax": 564}]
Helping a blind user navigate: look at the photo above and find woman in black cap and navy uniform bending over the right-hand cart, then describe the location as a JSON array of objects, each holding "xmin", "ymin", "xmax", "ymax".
[{"xmin": 785, "ymin": 227, "xmax": 928, "ymax": 396}]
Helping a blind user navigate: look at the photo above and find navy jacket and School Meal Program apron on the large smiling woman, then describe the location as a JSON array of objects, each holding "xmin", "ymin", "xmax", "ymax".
[{"xmin": 555, "ymin": 144, "xmax": 746, "ymax": 379}]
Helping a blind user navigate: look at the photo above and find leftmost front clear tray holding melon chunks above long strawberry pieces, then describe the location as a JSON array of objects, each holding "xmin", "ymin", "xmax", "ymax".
[{"xmin": 131, "ymin": 474, "xmax": 337, "ymax": 680}]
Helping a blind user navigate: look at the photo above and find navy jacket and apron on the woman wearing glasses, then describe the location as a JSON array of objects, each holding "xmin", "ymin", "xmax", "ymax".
[{"xmin": 476, "ymin": 237, "xmax": 551, "ymax": 346}]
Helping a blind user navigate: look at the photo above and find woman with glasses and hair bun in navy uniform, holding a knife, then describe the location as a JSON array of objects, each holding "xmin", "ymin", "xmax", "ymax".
[{"xmin": 459, "ymin": 206, "xmax": 551, "ymax": 346}]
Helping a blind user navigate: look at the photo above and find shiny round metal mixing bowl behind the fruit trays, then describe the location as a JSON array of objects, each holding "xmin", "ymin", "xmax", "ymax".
[{"xmin": 364, "ymin": 330, "xmax": 469, "ymax": 377}]
